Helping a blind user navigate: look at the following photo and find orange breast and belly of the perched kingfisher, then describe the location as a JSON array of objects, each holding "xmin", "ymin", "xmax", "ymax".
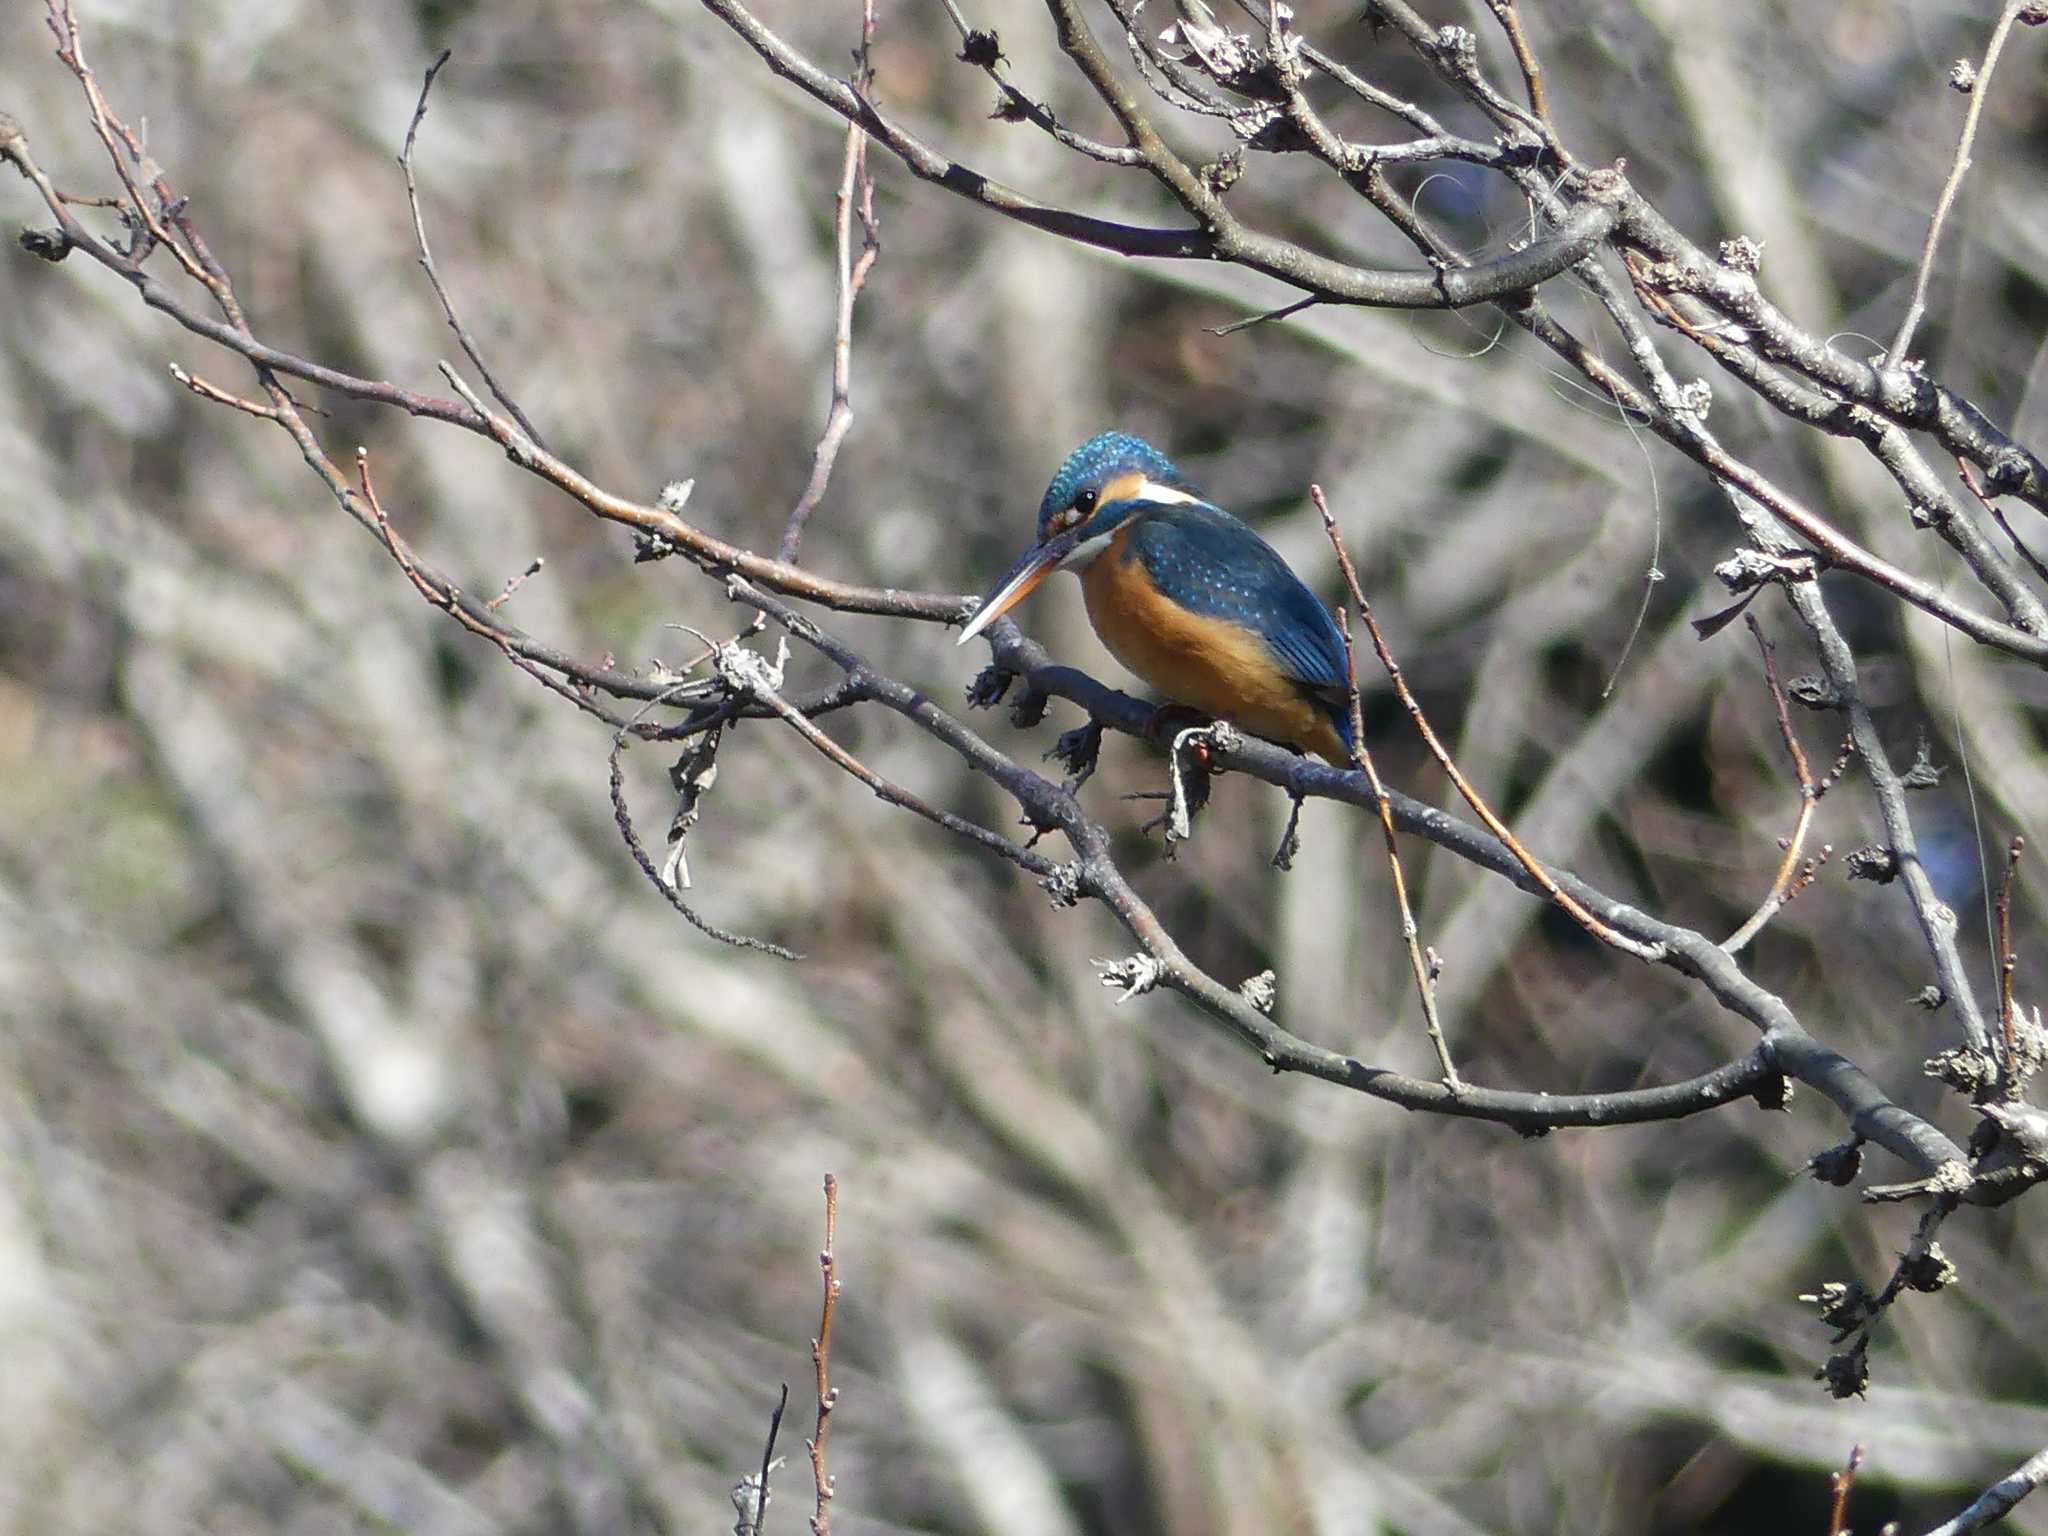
[{"xmin": 1081, "ymin": 524, "xmax": 1350, "ymax": 764}]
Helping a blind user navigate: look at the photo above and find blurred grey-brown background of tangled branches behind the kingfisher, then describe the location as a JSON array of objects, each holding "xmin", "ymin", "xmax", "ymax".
[{"xmin": 0, "ymin": 0, "xmax": 2048, "ymax": 1536}]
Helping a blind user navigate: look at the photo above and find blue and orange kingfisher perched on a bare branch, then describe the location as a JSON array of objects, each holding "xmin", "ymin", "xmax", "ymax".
[{"xmin": 958, "ymin": 432, "xmax": 1352, "ymax": 768}]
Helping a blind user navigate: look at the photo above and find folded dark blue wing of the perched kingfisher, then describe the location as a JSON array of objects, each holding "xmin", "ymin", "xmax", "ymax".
[{"xmin": 1130, "ymin": 502, "xmax": 1348, "ymax": 696}]
